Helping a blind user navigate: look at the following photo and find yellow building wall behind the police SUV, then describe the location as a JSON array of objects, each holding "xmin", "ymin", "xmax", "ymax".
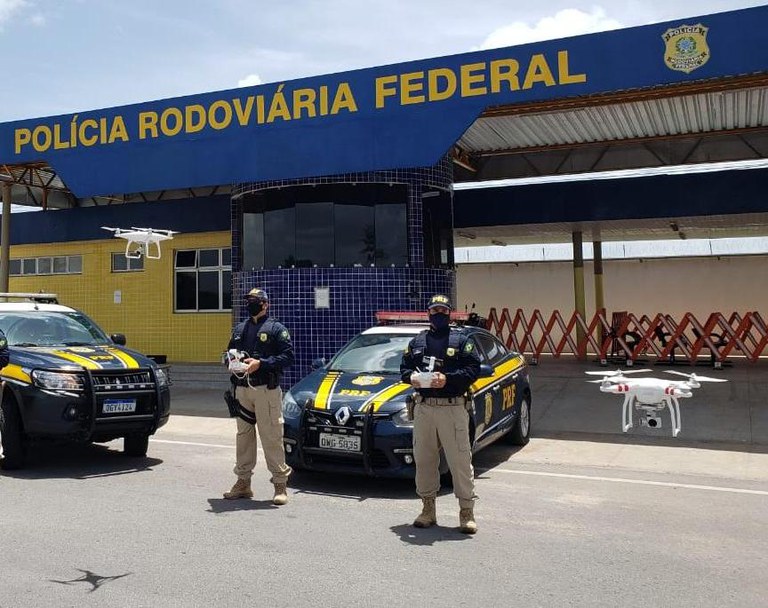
[{"xmin": 9, "ymin": 231, "xmax": 232, "ymax": 363}]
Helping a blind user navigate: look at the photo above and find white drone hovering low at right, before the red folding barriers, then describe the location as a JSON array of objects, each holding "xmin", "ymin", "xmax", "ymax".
[{"xmin": 585, "ymin": 369, "xmax": 728, "ymax": 437}]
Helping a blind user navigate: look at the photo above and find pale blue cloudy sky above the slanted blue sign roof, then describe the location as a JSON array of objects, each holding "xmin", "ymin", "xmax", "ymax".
[{"xmin": 0, "ymin": 0, "xmax": 765, "ymax": 122}]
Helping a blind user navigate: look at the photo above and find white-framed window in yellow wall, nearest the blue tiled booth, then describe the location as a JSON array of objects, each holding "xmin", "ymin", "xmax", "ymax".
[{"xmin": 174, "ymin": 248, "xmax": 232, "ymax": 312}]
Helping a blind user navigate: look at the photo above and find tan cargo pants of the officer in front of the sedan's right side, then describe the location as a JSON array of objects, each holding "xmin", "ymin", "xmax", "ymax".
[{"xmin": 413, "ymin": 403, "xmax": 475, "ymax": 509}]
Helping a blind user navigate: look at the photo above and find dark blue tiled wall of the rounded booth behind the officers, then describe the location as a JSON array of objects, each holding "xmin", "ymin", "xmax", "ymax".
[{"xmin": 232, "ymin": 159, "xmax": 455, "ymax": 387}]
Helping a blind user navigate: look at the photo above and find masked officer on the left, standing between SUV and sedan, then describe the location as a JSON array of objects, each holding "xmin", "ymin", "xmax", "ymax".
[{"xmin": 224, "ymin": 289, "xmax": 294, "ymax": 505}]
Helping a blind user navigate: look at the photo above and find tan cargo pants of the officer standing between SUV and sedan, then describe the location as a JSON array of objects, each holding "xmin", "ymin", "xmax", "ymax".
[{"xmin": 234, "ymin": 386, "xmax": 292, "ymax": 483}]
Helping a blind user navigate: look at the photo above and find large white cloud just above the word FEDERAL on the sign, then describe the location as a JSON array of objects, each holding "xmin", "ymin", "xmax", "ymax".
[{"xmin": 478, "ymin": 6, "xmax": 623, "ymax": 50}]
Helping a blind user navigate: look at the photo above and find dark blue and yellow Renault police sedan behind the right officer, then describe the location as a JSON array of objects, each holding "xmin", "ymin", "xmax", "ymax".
[{"xmin": 283, "ymin": 325, "xmax": 531, "ymax": 477}]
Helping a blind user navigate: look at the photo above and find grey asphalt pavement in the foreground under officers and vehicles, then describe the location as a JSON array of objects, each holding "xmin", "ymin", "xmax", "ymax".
[{"xmin": 0, "ymin": 415, "xmax": 768, "ymax": 608}]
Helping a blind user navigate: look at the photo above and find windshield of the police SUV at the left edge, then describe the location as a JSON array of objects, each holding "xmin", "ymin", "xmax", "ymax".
[{"xmin": 0, "ymin": 310, "xmax": 111, "ymax": 346}]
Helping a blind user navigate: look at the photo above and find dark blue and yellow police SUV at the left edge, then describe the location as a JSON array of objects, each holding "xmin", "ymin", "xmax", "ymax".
[{"xmin": 0, "ymin": 293, "xmax": 171, "ymax": 469}]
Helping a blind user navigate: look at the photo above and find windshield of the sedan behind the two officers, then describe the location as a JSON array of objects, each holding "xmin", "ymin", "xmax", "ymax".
[{"xmin": 328, "ymin": 334, "xmax": 413, "ymax": 374}]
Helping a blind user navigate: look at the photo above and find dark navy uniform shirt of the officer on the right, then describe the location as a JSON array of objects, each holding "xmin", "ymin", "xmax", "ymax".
[{"xmin": 400, "ymin": 328, "xmax": 480, "ymax": 397}]
